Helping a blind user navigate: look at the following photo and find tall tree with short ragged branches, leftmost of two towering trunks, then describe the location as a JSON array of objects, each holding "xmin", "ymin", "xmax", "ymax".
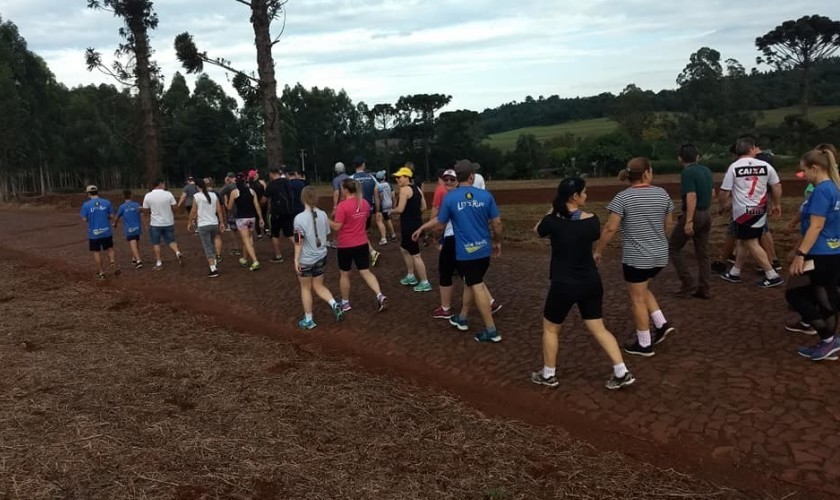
[{"xmin": 85, "ymin": 0, "xmax": 161, "ymax": 182}]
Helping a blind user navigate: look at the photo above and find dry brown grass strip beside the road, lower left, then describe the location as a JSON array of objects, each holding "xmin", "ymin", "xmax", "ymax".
[{"xmin": 0, "ymin": 261, "xmax": 741, "ymax": 499}]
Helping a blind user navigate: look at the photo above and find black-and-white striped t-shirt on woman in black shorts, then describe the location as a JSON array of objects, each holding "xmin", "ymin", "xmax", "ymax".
[{"xmin": 607, "ymin": 185, "xmax": 674, "ymax": 269}]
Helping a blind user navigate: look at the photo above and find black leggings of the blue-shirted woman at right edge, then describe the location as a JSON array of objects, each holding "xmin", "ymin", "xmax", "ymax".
[{"xmin": 785, "ymin": 255, "xmax": 840, "ymax": 339}]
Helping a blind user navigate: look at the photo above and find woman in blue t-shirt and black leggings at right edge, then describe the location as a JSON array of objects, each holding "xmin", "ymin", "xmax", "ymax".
[{"xmin": 785, "ymin": 149, "xmax": 840, "ymax": 361}]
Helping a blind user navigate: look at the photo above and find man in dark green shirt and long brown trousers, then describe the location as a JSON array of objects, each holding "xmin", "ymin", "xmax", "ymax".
[{"xmin": 668, "ymin": 144, "xmax": 713, "ymax": 299}]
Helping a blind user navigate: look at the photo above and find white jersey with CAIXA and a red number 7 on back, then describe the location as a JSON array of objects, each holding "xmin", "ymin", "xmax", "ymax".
[{"xmin": 720, "ymin": 157, "xmax": 779, "ymax": 228}]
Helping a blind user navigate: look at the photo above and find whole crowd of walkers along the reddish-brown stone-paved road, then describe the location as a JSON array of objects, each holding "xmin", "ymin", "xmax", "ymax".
[{"xmin": 81, "ymin": 136, "xmax": 840, "ymax": 390}]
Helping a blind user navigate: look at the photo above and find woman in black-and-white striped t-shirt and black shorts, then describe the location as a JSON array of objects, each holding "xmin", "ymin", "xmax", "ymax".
[{"xmin": 594, "ymin": 158, "xmax": 674, "ymax": 357}]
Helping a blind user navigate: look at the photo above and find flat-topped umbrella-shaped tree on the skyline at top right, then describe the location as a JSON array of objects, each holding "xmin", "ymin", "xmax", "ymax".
[{"xmin": 755, "ymin": 15, "xmax": 840, "ymax": 116}]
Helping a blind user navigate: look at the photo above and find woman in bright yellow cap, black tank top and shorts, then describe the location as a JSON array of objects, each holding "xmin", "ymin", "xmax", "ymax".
[{"xmin": 391, "ymin": 167, "xmax": 432, "ymax": 292}]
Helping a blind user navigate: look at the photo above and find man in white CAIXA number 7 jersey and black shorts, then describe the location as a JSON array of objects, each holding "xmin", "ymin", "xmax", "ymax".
[{"xmin": 718, "ymin": 136, "xmax": 784, "ymax": 288}]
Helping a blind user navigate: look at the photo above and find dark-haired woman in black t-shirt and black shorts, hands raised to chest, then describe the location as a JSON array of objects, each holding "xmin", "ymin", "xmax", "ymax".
[{"xmin": 531, "ymin": 178, "xmax": 636, "ymax": 390}]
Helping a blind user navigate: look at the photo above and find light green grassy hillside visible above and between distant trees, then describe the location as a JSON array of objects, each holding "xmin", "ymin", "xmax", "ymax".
[{"xmin": 486, "ymin": 106, "xmax": 840, "ymax": 152}]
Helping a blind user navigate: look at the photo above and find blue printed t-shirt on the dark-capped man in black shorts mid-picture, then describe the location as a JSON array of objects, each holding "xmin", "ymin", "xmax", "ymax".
[{"xmin": 437, "ymin": 186, "xmax": 499, "ymax": 260}]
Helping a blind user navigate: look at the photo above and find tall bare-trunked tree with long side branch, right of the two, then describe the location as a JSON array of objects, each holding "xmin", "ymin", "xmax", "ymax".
[{"xmin": 175, "ymin": 0, "xmax": 288, "ymax": 167}]
